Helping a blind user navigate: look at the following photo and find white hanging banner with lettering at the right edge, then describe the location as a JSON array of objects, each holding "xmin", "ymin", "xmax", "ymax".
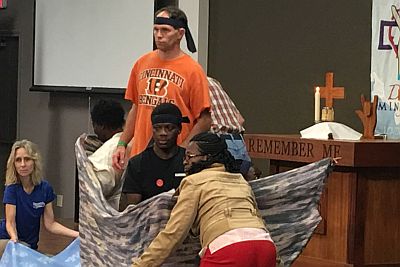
[{"xmin": 371, "ymin": 0, "xmax": 400, "ymax": 139}]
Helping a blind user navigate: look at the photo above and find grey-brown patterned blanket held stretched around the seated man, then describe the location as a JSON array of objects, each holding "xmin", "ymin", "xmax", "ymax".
[{"xmin": 75, "ymin": 135, "xmax": 331, "ymax": 266}]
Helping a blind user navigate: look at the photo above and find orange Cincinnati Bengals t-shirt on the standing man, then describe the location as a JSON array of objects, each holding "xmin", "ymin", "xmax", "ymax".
[{"xmin": 125, "ymin": 51, "xmax": 210, "ymax": 157}]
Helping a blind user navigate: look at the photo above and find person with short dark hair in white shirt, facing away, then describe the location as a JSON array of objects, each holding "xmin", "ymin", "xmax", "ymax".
[{"xmin": 88, "ymin": 99, "xmax": 125, "ymax": 210}]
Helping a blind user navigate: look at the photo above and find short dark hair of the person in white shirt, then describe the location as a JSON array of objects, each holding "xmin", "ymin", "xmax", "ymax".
[{"xmin": 90, "ymin": 99, "xmax": 125, "ymax": 130}]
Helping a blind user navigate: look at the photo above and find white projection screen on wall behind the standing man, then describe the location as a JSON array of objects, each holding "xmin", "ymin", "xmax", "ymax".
[{"xmin": 33, "ymin": 0, "xmax": 154, "ymax": 91}]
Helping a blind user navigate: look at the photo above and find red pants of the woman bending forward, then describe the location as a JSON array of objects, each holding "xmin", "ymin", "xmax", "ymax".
[{"xmin": 200, "ymin": 240, "xmax": 276, "ymax": 267}]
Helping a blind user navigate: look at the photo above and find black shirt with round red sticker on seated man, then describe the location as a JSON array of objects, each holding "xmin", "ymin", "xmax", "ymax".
[{"xmin": 122, "ymin": 146, "xmax": 185, "ymax": 201}]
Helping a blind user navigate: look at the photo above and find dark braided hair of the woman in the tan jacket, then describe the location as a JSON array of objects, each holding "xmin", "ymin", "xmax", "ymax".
[{"xmin": 189, "ymin": 132, "xmax": 240, "ymax": 174}]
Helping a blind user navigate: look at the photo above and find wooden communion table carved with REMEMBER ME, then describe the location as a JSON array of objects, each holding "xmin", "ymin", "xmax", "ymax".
[{"xmin": 245, "ymin": 134, "xmax": 400, "ymax": 267}]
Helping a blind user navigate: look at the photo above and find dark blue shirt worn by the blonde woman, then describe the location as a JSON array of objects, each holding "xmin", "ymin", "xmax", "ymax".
[{"xmin": 0, "ymin": 181, "xmax": 55, "ymax": 249}]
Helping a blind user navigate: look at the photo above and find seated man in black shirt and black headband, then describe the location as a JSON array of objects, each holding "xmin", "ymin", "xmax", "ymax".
[{"xmin": 121, "ymin": 103, "xmax": 189, "ymax": 209}]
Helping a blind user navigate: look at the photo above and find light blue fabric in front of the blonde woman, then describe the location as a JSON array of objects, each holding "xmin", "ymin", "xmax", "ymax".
[{"xmin": 0, "ymin": 238, "xmax": 81, "ymax": 267}]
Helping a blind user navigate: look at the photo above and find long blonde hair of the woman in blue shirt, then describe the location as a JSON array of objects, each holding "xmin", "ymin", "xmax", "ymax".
[{"xmin": 6, "ymin": 139, "xmax": 42, "ymax": 185}]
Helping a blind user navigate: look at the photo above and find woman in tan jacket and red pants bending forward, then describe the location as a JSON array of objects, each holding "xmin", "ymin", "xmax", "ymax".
[{"xmin": 133, "ymin": 132, "xmax": 276, "ymax": 267}]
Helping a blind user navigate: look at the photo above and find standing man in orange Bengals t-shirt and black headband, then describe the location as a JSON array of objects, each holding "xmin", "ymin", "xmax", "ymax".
[{"xmin": 113, "ymin": 4, "xmax": 211, "ymax": 169}]
